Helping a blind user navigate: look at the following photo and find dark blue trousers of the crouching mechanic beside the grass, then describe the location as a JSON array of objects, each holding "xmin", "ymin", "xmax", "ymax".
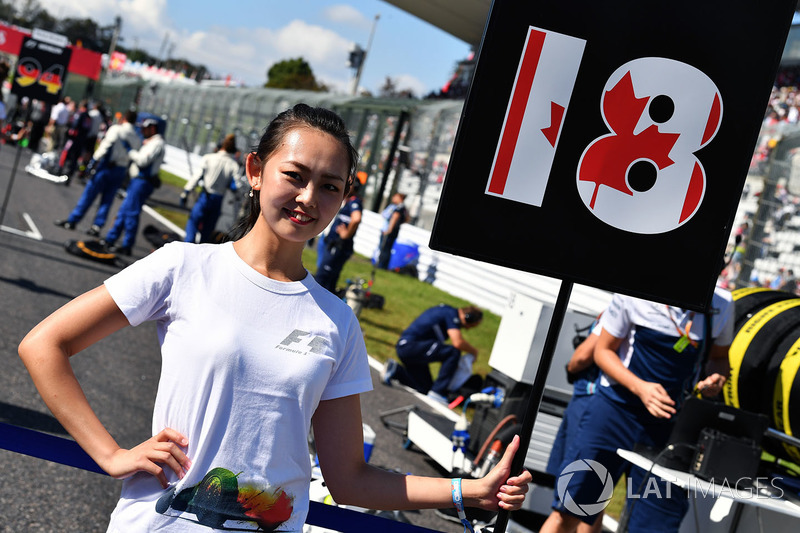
[{"xmin": 395, "ymin": 339, "xmax": 461, "ymax": 397}]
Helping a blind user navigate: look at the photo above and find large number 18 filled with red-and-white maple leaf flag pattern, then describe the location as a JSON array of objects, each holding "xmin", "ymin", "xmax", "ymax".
[{"xmin": 486, "ymin": 26, "xmax": 722, "ymax": 234}]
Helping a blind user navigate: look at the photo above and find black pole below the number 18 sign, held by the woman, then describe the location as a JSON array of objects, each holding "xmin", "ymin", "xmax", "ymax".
[{"xmin": 494, "ymin": 281, "xmax": 572, "ymax": 533}]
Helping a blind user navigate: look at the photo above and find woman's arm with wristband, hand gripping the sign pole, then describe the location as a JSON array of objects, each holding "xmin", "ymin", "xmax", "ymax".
[{"xmin": 313, "ymin": 395, "xmax": 531, "ymax": 511}]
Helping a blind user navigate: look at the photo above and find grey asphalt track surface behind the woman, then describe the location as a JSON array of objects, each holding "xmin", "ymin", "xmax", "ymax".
[{"xmin": 0, "ymin": 145, "xmax": 516, "ymax": 533}]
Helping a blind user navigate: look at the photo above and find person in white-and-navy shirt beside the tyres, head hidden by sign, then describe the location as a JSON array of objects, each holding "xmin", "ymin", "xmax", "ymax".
[{"xmin": 540, "ymin": 288, "xmax": 733, "ymax": 533}]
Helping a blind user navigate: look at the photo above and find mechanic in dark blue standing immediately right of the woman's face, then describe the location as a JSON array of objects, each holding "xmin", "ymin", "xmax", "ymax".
[{"xmin": 314, "ymin": 180, "xmax": 364, "ymax": 293}]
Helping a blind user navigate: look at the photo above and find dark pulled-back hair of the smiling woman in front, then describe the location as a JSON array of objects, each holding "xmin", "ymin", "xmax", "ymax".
[{"xmin": 226, "ymin": 104, "xmax": 358, "ymax": 241}]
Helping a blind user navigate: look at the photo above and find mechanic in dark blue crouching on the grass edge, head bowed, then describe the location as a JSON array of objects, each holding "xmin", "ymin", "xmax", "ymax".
[{"xmin": 381, "ymin": 304, "xmax": 483, "ymax": 403}]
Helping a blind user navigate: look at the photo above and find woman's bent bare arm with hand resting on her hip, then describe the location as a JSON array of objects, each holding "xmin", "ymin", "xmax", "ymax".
[{"xmin": 19, "ymin": 286, "xmax": 189, "ymax": 487}]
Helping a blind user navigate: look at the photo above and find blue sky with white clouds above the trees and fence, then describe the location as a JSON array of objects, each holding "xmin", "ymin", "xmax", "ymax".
[{"xmin": 41, "ymin": 0, "xmax": 470, "ymax": 96}]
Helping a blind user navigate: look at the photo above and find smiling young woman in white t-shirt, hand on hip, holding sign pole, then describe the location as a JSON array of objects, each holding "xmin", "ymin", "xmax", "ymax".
[{"xmin": 19, "ymin": 104, "xmax": 531, "ymax": 532}]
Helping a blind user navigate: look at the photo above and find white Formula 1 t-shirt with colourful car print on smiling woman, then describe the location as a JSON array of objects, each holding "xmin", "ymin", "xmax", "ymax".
[{"xmin": 105, "ymin": 242, "xmax": 372, "ymax": 532}]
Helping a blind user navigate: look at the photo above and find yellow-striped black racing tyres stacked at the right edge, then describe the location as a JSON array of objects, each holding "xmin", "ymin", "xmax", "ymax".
[{"xmin": 724, "ymin": 287, "xmax": 800, "ymax": 464}]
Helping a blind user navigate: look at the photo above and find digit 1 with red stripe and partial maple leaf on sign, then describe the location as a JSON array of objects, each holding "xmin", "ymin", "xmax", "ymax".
[{"xmin": 486, "ymin": 26, "xmax": 586, "ymax": 206}]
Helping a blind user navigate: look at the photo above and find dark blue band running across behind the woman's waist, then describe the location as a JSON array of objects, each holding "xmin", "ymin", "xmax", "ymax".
[{"xmin": 0, "ymin": 422, "xmax": 435, "ymax": 533}]
